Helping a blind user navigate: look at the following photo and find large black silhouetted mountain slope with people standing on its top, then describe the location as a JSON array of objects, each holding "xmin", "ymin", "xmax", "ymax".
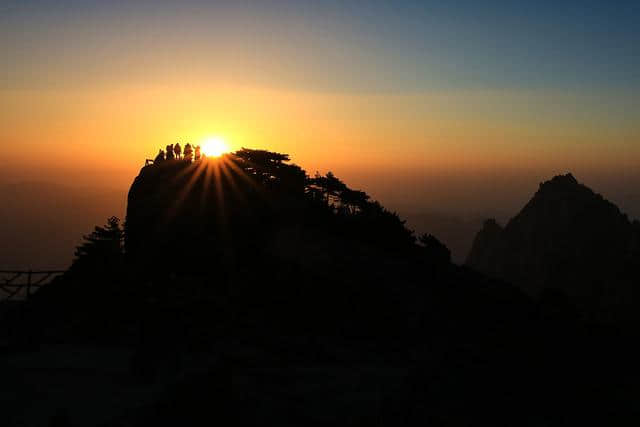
[{"xmin": 6, "ymin": 155, "xmax": 637, "ymax": 426}]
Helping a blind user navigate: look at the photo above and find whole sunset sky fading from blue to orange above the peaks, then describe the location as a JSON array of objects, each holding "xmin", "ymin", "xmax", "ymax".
[{"xmin": 0, "ymin": 0, "xmax": 640, "ymax": 213}]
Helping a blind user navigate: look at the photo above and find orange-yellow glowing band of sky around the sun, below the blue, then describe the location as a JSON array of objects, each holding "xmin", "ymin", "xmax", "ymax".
[{"xmin": 0, "ymin": 81, "xmax": 640, "ymax": 197}]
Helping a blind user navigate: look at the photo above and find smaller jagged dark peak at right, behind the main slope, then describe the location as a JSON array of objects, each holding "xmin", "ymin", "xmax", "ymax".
[{"xmin": 466, "ymin": 174, "xmax": 640, "ymax": 317}]
